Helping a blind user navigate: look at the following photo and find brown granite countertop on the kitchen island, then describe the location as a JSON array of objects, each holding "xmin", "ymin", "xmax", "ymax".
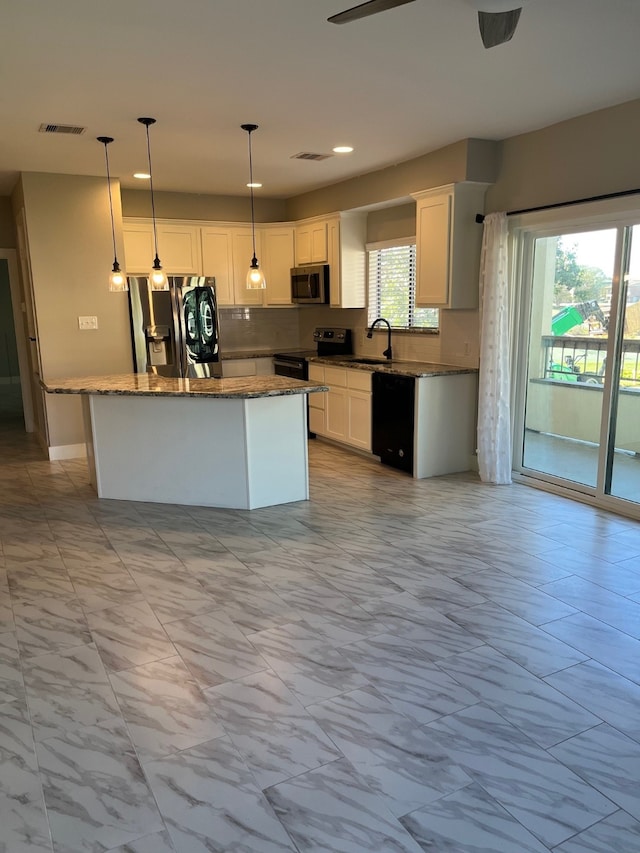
[{"xmin": 41, "ymin": 373, "xmax": 329, "ymax": 399}]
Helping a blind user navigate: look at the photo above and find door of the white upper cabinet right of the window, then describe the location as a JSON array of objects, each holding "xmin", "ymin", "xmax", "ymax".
[{"xmin": 416, "ymin": 193, "xmax": 453, "ymax": 308}]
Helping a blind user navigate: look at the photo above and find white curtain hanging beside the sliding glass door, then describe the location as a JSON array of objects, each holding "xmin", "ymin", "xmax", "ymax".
[{"xmin": 478, "ymin": 213, "xmax": 511, "ymax": 484}]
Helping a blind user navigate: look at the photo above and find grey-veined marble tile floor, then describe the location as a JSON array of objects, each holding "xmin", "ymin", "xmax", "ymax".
[{"xmin": 0, "ymin": 426, "xmax": 640, "ymax": 853}]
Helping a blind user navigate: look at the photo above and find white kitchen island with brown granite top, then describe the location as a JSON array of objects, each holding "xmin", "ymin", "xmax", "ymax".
[{"xmin": 43, "ymin": 373, "xmax": 327, "ymax": 509}]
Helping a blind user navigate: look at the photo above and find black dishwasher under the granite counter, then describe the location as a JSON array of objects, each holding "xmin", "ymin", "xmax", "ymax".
[{"xmin": 371, "ymin": 373, "xmax": 416, "ymax": 474}]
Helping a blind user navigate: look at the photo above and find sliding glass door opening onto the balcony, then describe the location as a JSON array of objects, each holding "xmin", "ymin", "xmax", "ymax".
[{"xmin": 515, "ymin": 220, "xmax": 640, "ymax": 503}]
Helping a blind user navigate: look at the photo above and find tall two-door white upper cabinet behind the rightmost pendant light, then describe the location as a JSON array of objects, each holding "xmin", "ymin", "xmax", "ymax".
[{"xmin": 201, "ymin": 226, "xmax": 263, "ymax": 305}]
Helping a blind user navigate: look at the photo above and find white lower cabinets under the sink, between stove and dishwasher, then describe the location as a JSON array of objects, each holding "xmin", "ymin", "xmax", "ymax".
[{"xmin": 309, "ymin": 364, "xmax": 371, "ymax": 451}]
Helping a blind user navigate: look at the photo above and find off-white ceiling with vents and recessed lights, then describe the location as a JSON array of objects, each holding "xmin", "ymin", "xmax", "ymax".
[{"xmin": 0, "ymin": 0, "xmax": 640, "ymax": 198}]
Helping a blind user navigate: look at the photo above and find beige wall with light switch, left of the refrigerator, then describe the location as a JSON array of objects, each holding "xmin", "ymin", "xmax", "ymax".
[{"xmin": 14, "ymin": 172, "xmax": 132, "ymax": 447}]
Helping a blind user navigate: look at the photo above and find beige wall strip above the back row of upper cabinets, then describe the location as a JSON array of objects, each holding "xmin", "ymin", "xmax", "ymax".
[{"xmin": 122, "ymin": 189, "xmax": 286, "ymax": 222}]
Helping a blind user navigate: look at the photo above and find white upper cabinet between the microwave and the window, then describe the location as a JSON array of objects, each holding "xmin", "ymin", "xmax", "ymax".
[{"xmin": 327, "ymin": 212, "xmax": 367, "ymax": 308}]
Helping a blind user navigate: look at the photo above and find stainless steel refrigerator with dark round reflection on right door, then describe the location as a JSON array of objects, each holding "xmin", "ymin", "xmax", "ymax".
[{"xmin": 127, "ymin": 276, "xmax": 222, "ymax": 378}]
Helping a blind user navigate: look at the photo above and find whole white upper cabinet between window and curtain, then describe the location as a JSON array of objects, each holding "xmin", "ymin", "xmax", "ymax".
[{"xmin": 412, "ymin": 183, "xmax": 487, "ymax": 309}]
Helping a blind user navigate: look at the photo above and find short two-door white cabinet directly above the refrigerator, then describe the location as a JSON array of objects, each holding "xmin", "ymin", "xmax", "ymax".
[{"xmin": 123, "ymin": 221, "xmax": 202, "ymax": 275}]
